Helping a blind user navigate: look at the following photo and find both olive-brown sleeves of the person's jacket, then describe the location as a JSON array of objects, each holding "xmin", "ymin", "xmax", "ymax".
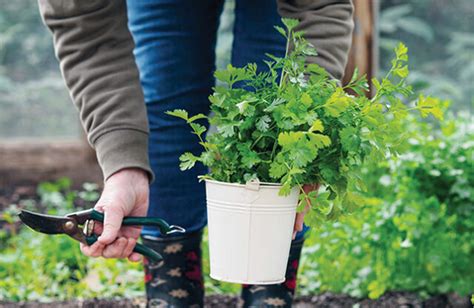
[{"xmin": 38, "ymin": 0, "xmax": 353, "ymax": 179}]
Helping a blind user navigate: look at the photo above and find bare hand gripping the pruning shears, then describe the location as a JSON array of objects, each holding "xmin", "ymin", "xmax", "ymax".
[{"xmin": 81, "ymin": 168, "xmax": 149, "ymax": 262}]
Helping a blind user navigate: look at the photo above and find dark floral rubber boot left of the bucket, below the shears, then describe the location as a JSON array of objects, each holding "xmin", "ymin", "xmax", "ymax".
[{"xmin": 143, "ymin": 232, "xmax": 204, "ymax": 308}]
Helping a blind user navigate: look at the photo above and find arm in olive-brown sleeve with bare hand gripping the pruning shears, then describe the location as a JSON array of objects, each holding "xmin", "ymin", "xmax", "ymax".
[{"xmin": 39, "ymin": 0, "xmax": 152, "ymax": 261}]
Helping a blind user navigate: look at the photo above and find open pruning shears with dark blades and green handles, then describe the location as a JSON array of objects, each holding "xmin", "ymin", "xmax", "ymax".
[{"xmin": 18, "ymin": 209, "xmax": 186, "ymax": 262}]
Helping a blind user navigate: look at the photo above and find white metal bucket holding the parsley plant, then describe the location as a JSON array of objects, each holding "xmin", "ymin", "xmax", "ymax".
[{"xmin": 206, "ymin": 180, "xmax": 298, "ymax": 284}]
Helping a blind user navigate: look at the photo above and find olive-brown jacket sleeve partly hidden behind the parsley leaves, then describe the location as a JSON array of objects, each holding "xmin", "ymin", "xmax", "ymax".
[{"xmin": 277, "ymin": 0, "xmax": 354, "ymax": 80}]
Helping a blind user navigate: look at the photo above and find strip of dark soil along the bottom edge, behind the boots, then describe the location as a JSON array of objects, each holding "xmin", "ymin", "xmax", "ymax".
[{"xmin": 0, "ymin": 292, "xmax": 473, "ymax": 308}]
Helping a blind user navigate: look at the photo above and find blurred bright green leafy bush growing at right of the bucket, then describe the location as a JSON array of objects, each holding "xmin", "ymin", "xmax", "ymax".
[{"xmin": 301, "ymin": 114, "xmax": 474, "ymax": 298}]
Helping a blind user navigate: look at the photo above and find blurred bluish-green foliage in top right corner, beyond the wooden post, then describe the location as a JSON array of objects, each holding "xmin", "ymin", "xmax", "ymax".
[{"xmin": 378, "ymin": 0, "xmax": 474, "ymax": 110}]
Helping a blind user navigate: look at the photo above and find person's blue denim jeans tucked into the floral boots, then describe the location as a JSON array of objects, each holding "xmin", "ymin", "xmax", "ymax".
[{"xmin": 124, "ymin": 0, "xmax": 308, "ymax": 236}]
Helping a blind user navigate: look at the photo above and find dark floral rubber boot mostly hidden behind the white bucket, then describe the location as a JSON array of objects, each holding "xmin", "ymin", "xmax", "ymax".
[{"xmin": 242, "ymin": 238, "xmax": 304, "ymax": 308}]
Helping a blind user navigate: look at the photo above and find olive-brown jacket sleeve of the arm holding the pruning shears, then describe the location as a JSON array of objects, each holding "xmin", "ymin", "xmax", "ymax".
[{"xmin": 39, "ymin": 0, "xmax": 152, "ymax": 179}]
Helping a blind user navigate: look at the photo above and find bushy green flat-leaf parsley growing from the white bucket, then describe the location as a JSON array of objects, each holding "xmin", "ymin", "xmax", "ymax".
[{"xmin": 167, "ymin": 19, "xmax": 444, "ymax": 221}]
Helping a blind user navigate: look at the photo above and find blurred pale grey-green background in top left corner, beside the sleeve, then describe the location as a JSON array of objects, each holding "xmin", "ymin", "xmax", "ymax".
[{"xmin": 0, "ymin": 0, "xmax": 80, "ymax": 138}]
